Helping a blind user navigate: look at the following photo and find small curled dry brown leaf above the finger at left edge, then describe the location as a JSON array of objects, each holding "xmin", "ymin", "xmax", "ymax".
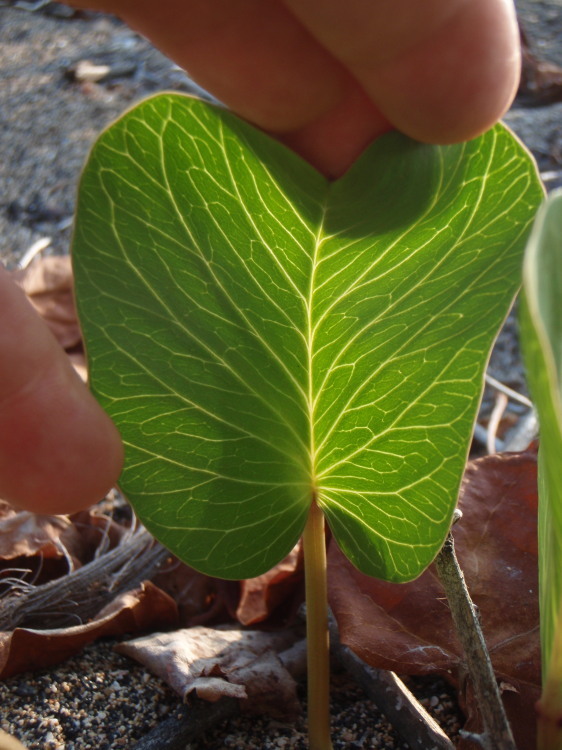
[{"xmin": 12, "ymin": 255, "xmax": 82, "ymax": 349}]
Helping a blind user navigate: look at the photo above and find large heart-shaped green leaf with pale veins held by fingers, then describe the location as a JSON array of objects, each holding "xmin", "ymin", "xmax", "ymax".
[{"xmin": 74, "ymin": 94, "xmax": 541, "ymax": 581}]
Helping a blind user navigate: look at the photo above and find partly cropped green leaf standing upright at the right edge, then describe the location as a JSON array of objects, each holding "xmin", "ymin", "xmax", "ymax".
[{"xmin": 521, "ymin": 191, "xmax": 562, "ymax": 680}]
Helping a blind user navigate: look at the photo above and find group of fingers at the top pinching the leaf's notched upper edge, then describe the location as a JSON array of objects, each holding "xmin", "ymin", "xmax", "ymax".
[{"xmin": 69, "ymin": 0, "xmax": 520, "ymax": 176}]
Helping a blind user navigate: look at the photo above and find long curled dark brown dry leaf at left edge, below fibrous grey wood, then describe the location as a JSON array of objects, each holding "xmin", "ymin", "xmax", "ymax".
[{"xmin": 0, "ymin": 581, "xmax": 178, "ymax": 679}]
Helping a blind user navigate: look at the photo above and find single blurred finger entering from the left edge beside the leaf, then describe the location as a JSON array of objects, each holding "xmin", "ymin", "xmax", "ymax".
[{"xmin": 0, "ymin": 268, "xmax": 123, "ymax": 513}]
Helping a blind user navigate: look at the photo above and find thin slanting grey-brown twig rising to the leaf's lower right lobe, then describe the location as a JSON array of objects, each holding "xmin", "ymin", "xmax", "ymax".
[{"xmin": 435, "ymin": 533, "xmax": 516, "ymax": 750}]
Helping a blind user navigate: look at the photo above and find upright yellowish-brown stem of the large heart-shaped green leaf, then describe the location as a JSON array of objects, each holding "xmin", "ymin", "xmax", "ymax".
[{"xmin": 303, "ymin": 499, "xmax": 332, "ymax": 750}]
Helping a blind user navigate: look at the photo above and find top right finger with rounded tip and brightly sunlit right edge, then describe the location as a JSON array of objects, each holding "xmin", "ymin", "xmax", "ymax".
[{"xmin": 285, "ymin": 0, "xmax": 520, "ymax": 143}]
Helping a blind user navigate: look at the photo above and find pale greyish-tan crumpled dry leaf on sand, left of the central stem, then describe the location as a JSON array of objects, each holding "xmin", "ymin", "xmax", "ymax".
[{"xmin": 116, "ymin": 626, "xmax": 299, "ymax": 719}]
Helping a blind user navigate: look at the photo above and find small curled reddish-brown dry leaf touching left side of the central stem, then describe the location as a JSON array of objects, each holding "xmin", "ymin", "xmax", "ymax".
[{"xmin": 236, "ymin": 542, "xmax": 303, "ymax": 625}]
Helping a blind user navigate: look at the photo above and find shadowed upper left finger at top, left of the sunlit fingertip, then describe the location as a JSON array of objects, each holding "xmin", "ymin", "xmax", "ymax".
[{"xmin": 72, "ymin": 0, "xmax": 347, "ymax": 132}]
